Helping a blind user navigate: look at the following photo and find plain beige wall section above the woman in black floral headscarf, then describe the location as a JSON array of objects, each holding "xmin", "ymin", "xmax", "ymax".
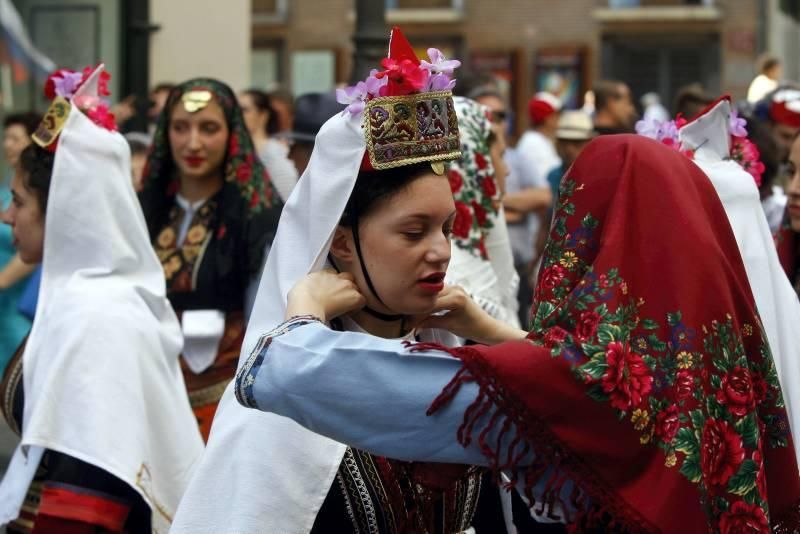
[{"xmin": 150, "ymin": 0, "xmax": 251, "ymax": 90}]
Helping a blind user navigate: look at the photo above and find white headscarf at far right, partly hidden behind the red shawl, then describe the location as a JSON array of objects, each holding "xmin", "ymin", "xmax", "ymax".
[{"xmin": 679, "ymin": 100, "xmax": 800, "ymax": 465}]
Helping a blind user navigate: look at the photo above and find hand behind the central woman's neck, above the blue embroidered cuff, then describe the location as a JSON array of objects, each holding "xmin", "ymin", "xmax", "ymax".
[{"xmin": 286, "ymin": 269, "xmax": 366, "ymax": 322}]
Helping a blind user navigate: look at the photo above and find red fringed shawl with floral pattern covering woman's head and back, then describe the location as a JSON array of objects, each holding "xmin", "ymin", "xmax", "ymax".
[{"xmin": 422, "ymin": 135, "xmax": 800, "ymax": 533}]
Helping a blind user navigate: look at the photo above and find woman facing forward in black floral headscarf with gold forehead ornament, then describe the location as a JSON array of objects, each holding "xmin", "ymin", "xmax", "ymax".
[{"xmin": 140, "ymin": 79, "xmax": 281, "ymax": 438}]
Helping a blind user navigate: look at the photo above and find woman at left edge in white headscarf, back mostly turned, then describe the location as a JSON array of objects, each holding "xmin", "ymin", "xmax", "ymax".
[{"xmin": 0, "ymin": 66, "xmax": 203, "ymax": 533}]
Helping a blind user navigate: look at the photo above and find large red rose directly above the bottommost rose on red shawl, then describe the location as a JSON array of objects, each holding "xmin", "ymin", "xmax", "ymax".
[{"xmin": 700, "ymin": 417, "xmax": 745, "ymax": 489}]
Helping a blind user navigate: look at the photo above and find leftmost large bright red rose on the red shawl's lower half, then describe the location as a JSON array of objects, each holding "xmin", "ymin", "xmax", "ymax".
[{"xmin": 600, "ymin": 341, "xmax": 653, "ymax": 411}]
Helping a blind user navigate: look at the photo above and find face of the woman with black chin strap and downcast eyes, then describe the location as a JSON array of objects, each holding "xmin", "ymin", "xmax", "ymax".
[{"xmin": 334, "ymin": 172, "xmax": 455, "ymax": 315}]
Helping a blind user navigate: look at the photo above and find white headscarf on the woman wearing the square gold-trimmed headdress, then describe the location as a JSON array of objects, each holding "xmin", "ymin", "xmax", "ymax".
[{"xmin": 172, "ymin": 103, "xmax": 455, "ymax": 534}]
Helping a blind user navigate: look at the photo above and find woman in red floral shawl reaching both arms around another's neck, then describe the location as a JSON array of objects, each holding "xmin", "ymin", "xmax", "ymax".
[{"xmin": 237, "ymin": 136, "xmax": 800, "ymax": 533}]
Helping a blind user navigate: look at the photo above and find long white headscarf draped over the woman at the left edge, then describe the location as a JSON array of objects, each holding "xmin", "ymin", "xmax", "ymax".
[{"xmin": 0, "ymin": 66, "xmax": 203, "ymax": 532}]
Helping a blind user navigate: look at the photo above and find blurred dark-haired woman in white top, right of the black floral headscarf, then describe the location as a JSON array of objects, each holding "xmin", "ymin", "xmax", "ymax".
[{"xmin": 239, "ymin": 89, "xmax": 298, "ymax": 202}]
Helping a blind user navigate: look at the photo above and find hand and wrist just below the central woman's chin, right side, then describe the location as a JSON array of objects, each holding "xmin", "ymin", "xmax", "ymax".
[{"xmin": 414, "ymin": 286, "xmax": 528, "ymax": 345}]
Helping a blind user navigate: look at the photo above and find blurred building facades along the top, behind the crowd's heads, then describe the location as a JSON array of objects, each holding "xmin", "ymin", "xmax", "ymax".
[{"xmin": 2, "ymin": 0, "xmax": 800, "ymax": 136}]
